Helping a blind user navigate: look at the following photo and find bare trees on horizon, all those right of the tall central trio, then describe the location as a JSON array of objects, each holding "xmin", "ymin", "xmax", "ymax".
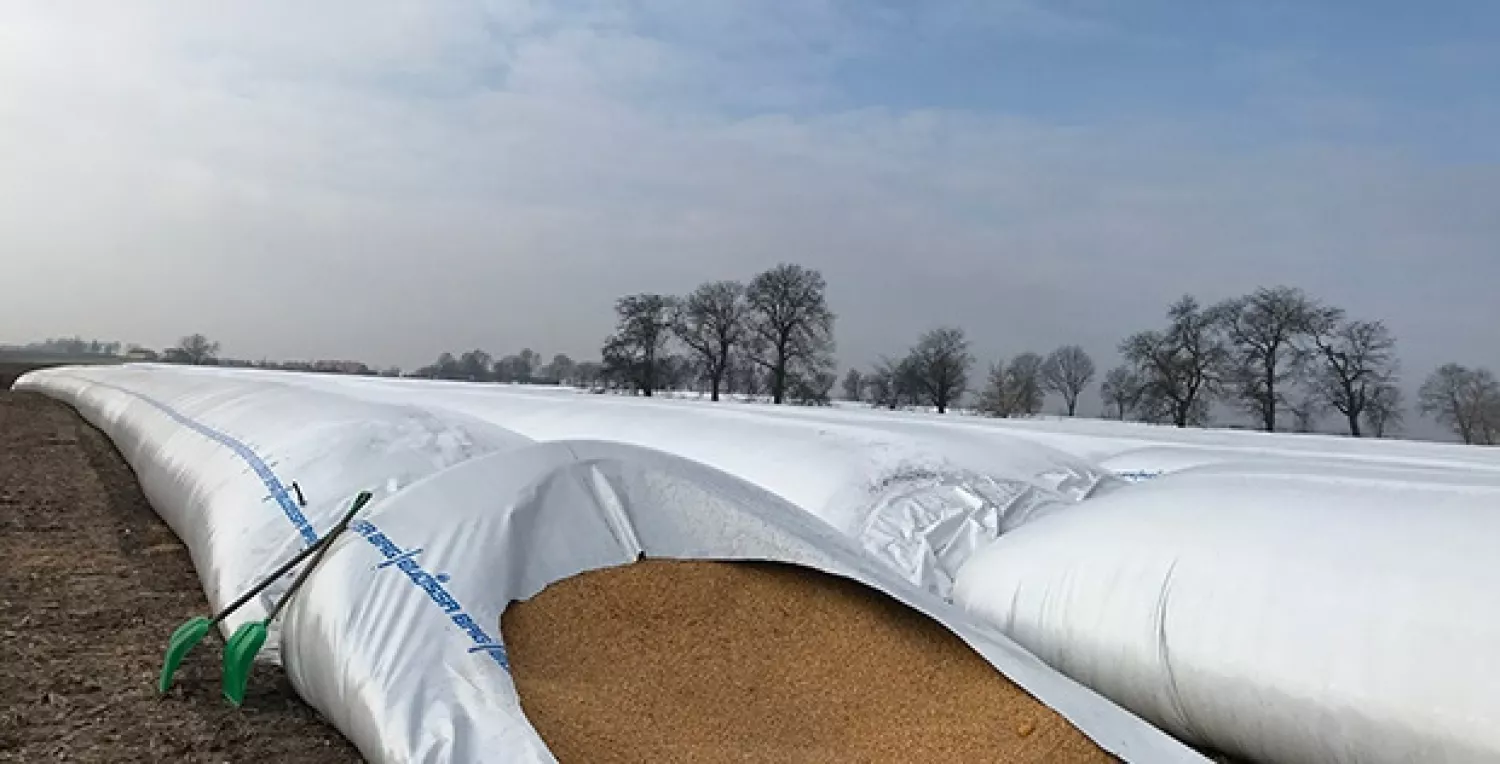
[{"xmin": 845, "ymin": 287, "xmax": 1416, "ymax": 438}]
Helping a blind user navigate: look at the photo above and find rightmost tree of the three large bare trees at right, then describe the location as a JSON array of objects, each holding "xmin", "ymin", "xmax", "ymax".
[{"xmin": 1310, "ymin": 308, "xmax": 1398, "ymax": 438}]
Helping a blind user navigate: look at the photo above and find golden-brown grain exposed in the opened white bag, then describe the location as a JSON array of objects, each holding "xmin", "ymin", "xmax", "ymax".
[{"xmin": 501, "ymin": 560, "xmax": 1116, "ymax": 764}]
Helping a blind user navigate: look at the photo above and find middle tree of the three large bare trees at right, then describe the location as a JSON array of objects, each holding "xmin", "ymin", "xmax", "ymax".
[{"xmin": 1214, "ymin": 287, "xmax": 1319, "ymax": 432}]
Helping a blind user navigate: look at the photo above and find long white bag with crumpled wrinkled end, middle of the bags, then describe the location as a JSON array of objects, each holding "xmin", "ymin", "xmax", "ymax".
[{"xmin": 195, "ymin": 371, "xmax": 1124, "ymax": 596}]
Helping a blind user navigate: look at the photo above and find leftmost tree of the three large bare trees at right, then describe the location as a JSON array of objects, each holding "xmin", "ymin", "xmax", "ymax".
[{"xmin": 1121, "ymin": 296, "xmax": 1229, "ymax": 428}]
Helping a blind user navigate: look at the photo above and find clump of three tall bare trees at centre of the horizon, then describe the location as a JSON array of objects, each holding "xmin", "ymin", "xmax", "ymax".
[{"xmin": 603, "ymin": 263, "xmax": 834, "ymax": 404}]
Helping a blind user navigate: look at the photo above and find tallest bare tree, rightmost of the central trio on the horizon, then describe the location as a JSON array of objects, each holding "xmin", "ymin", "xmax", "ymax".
[{"xmin": 746, "ymin": 263, "xmax": 834, "ymax": 404}]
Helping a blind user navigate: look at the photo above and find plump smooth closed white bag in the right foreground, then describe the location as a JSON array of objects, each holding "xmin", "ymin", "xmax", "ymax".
[{"xmin": 954, "ymin": 459, "xmax": 1500, "ymax": 764}]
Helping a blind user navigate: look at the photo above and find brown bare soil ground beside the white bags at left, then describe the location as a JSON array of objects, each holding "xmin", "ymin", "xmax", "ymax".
[{"xmin": 0, "ymin": 390, "xmax": 360, "ymax": 764}]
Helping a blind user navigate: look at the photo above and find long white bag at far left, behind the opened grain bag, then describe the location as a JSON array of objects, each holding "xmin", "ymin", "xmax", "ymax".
[{"xmin": 8, "ymin": 366, "xmax": 531, "ymax": 657}]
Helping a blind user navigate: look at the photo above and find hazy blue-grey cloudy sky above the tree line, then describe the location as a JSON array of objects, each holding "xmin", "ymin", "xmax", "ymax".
[{"xmin": 0, "ymin": 0, "xmax": 1500, "ymax": 417}]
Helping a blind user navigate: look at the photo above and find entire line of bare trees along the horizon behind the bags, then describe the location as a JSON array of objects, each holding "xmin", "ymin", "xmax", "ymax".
[{"xmin": 162, "ymin": 282, "xmax": 1500, "ymax": 444}]
